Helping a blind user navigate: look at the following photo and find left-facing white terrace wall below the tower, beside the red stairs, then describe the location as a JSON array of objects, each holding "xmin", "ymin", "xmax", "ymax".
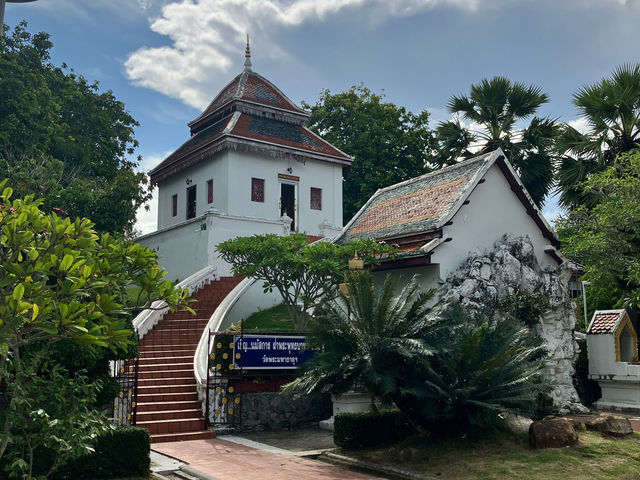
[{"xmin": 136, "ymin": 217, "xmax": 209, "ymax": 281}]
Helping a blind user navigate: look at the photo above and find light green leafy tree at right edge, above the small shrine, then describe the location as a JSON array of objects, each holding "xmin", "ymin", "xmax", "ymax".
[{"xmin": 556, "ymin": 152, "xmax": 640, "ymax": 309}]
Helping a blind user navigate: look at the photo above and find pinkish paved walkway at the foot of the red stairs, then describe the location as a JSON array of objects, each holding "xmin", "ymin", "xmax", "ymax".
[{"xmin": 151, "ymin": 438, "xmax": 377, "ymax": 480}]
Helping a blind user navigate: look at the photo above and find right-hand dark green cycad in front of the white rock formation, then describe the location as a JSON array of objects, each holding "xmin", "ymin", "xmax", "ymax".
[{"xmin": 416, "ymin": 305, "xmax": 549, "ymax": 430}]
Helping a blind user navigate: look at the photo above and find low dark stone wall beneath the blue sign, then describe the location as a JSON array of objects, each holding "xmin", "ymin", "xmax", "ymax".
[{"xmin": 241, "ymin": 392, "xmax": 332, "ymax": 432}]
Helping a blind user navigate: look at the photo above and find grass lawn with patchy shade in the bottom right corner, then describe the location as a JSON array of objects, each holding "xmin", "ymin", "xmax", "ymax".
[{"xmin": 345, "ymin": 432, "xmax": 640, "ymax": 480}]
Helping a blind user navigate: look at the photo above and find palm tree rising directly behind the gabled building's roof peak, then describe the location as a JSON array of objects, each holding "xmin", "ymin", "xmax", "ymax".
[{"xmin": 433, "ymin": 77, "xmax": 558, "ymax": 207}]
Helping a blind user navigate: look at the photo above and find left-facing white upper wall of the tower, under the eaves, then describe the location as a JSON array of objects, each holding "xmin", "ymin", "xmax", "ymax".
[{"xmin": 158, "ymin": 152, "xmax": 229, "ymax": 230}]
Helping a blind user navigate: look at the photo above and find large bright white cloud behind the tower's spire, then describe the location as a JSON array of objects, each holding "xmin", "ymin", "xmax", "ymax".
[{"xmin": 125, "ymin": 0, "xmax": 504, "ymax": 109}]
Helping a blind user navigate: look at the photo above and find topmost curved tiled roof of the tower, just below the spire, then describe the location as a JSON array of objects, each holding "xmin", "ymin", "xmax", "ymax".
[{"xmin": 191, "ymin": 70, "xmax": 308, "ymax": 123}]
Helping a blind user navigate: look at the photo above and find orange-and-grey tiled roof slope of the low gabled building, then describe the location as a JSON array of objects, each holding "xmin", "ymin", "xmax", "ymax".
[{"xmin": 341, "ymin": 152, "xmax": 495, "ymax": 241}]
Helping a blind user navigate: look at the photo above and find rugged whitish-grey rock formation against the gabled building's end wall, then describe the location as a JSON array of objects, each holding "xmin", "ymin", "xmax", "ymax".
[{"xmin": 436, "ymin": 234, "xmax": 586, "ymax": 413}]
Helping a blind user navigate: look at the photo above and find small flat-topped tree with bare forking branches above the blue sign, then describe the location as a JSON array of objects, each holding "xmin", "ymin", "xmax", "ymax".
[{"xmin": 216, "ymin": 233, "xmax": 396, "ymax": 331}]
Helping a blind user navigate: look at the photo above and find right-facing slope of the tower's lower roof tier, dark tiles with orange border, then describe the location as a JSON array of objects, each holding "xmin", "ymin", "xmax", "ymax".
[{"xmin": 231, "ymin": 113, "xmax": 351, "ymax": 161}]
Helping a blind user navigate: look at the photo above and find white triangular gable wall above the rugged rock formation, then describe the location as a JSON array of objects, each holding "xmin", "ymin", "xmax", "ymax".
[{"xmin": 431, "ymin": 165, "xmax": 558, "ymax": 279}]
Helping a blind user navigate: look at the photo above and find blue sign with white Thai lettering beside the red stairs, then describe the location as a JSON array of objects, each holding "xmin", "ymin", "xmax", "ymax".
[{"xmin": 233, "ymin": 335, "xmax": 314, "ymax": 370}]
